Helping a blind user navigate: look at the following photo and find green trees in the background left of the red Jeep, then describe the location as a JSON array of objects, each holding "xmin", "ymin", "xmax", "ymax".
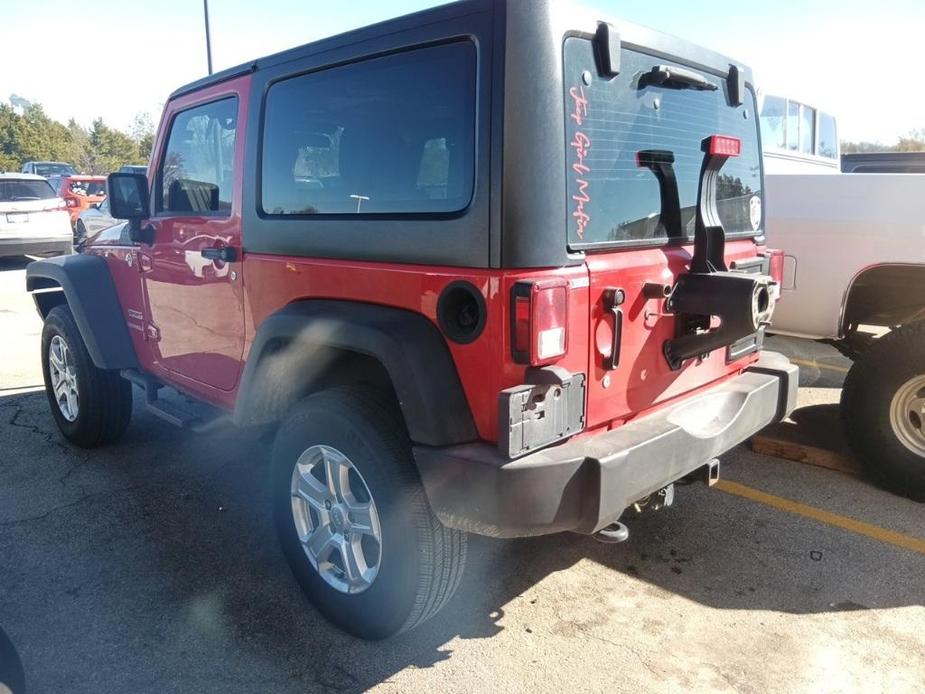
[{"xmin": 0, "ymin": 103, "xmax": 154, "ymax": 174}]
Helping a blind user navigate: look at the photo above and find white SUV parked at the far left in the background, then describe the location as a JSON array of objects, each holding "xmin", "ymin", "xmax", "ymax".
[{"xmin": 0, "ymin": 173, "xmax": 73, "ymax": 257}]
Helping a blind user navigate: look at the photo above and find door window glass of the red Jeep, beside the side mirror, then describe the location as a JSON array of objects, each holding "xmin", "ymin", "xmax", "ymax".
[{"xmin": 156, "ymin": 97, "xmax": 238, "ymax": 216}]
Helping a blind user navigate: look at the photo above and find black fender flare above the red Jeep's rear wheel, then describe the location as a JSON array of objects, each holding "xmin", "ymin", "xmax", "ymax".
[{"xmin": 234, "ymin": 299, "xmax": 478, "ymax": 446}]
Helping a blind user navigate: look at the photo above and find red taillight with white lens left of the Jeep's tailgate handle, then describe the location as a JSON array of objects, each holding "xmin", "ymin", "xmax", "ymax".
[{"xmin": 511, "ymin": 279, "xmax": 568, "ymax": 366}]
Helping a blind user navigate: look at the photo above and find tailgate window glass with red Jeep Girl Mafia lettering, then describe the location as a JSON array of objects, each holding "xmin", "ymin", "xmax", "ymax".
[{"xmin": 565, "ymin": 38, "xmax": 761, "ymax": 247}]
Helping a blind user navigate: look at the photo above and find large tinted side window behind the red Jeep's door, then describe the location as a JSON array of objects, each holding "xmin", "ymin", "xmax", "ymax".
[{"xmin": 261, "ymin": 41, "xmax": 476, "ymax": 215}]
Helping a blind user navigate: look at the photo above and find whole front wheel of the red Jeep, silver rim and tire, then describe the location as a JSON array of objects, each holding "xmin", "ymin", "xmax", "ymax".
[{"xmin": 42, "ymin": 304, "xmax": 132, "ymax": 448}]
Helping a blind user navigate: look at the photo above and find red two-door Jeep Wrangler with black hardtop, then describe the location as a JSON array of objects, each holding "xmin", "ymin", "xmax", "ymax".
[{"xmin": 27, "ymin": 0, "xmax": 797, "ymax": 638}]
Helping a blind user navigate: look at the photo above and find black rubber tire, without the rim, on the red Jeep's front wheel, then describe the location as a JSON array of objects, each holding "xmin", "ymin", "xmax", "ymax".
[{"xmin": 42, "ymin": 305, "xmax": 132, "ymax": 448}]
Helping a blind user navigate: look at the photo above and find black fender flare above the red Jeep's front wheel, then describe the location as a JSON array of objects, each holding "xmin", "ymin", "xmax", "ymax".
[{"xmin": 26, "ymin": 254, "xmax": 138, "ymax": 369}]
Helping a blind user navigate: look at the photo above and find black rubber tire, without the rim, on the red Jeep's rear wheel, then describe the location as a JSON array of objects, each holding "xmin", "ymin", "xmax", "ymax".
[{"xmin": 273, "ymin": 387, "xmax": 467, "ymax": 639}]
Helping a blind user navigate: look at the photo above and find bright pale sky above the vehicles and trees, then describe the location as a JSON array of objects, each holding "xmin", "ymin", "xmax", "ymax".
[{"xmin": 0, "ymin": 0, "xmax": 925, "ymax": 144}]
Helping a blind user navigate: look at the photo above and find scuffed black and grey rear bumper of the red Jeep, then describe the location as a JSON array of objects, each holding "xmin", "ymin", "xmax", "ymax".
[{"xmin": 414, "ymin": 352, "xmax": 799, "ymax": 537}]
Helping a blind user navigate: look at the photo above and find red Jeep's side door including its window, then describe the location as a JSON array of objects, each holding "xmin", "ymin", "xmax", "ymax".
[{"xmin": 141, "ymin": 78, "xmax": 249, "ymax": 391}]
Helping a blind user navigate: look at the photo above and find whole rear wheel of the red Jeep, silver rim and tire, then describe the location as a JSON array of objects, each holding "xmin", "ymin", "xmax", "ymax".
[{"xmin": 272, "ymin": 387, "xmax": 466, "ymax": 639}]
